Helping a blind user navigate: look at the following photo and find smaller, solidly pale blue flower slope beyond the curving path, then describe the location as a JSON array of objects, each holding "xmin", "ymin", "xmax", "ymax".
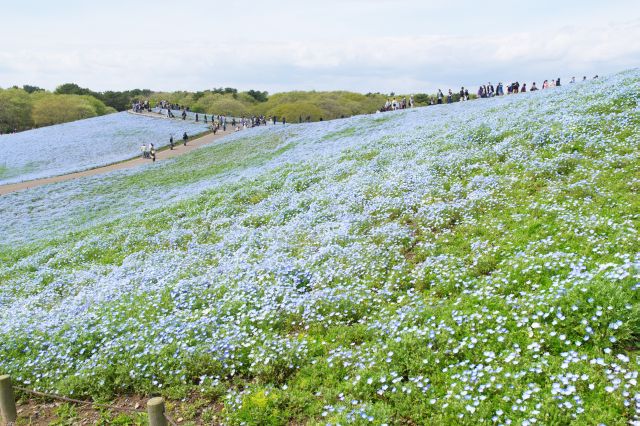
[{"xmin": 0, "ymin": 112, "xmax": 207, "ymax": 185}]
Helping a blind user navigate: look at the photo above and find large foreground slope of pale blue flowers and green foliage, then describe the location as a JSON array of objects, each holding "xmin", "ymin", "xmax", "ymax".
[{"xmin": 0, "ymin": 70, "xmax": 640, "ymax": 424}]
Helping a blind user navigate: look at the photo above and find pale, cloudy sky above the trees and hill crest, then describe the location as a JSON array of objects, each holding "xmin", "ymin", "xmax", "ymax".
[{"xmin": 0, "ymin": 0, "xmax": 640, "ymax": 93}]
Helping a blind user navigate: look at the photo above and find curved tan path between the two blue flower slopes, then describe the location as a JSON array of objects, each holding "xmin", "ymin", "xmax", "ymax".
[{"xmin": 0, "ymin": 114, "xmax": 235, "ymax": 196}]
